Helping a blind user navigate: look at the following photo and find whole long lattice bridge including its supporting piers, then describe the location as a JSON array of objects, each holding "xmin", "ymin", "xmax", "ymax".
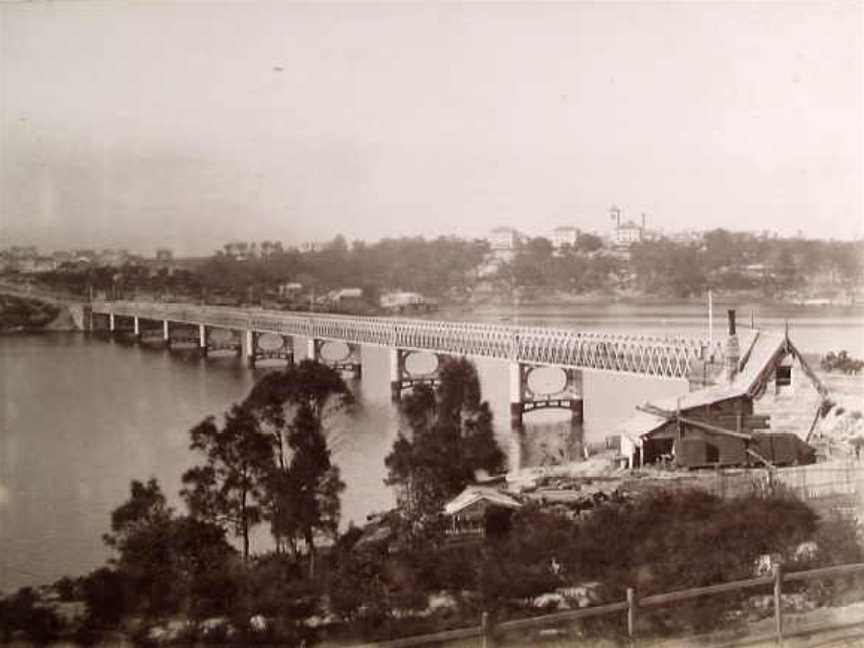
[{"xmin": 90, "ymin": 301, "xmax": 724, "ymax": 426}]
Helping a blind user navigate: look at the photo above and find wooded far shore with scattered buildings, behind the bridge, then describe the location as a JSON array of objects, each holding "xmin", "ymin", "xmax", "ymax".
[{"xmin": 11, "ymin": 229, "xmax": 864, "ymax": 310}]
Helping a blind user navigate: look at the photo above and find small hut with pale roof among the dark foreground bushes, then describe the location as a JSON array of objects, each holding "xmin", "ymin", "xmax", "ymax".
[{"xmin": 444, "ymin": 486, "xmax": 522, "ymax": 537}]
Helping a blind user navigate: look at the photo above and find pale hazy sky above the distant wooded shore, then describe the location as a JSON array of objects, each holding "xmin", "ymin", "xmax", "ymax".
[{"xmin": 0, "ymin": 0, "xmax": 864, "ymax": 255}]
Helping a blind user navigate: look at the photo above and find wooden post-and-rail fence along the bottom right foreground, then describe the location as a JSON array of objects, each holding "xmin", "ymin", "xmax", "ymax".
[{"xmin": 357, "ymin": 563, "xmax": 864, "ymax": 648}]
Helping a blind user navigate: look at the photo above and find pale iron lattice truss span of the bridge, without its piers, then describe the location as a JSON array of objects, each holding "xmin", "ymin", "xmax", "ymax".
[{"xmin": 92, "ymin": 301, "xmax": 723, "ymax": 378}]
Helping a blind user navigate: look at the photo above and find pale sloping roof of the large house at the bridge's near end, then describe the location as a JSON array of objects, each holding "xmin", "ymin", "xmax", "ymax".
[{"xmin": 617, "ymin": 331, "xmax": 828, "ymax": 441}]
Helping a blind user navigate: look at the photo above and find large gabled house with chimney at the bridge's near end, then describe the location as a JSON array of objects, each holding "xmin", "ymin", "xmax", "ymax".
[{"xmin": 618, "ymin": 316, "xmax": 828, "ymax": 468}]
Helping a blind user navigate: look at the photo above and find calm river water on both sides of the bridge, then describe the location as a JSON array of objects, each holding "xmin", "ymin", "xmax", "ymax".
[{"xmin": 0, "ymin": 305, "xmax": 864, "ymax": 592}]
